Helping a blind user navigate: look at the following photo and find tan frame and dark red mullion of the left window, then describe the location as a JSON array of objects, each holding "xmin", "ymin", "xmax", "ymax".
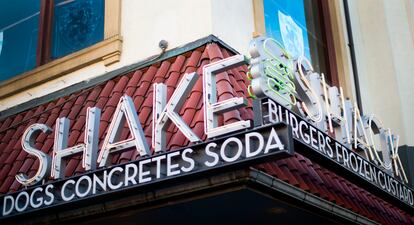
[{"xmin": 0, "ymin": 0, "xmax": 122, "ymax": 99}]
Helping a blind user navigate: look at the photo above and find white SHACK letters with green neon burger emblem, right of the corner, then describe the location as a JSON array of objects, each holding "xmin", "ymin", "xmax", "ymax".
[{"xmin": 249, "ymin": 37, "xmax": 408, "ymax": 183}]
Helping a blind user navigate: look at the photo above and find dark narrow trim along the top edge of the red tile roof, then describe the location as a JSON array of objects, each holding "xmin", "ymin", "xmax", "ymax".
[{"xmin": 0, "ymin": 34, "xmax": 239, "ymax": 121}]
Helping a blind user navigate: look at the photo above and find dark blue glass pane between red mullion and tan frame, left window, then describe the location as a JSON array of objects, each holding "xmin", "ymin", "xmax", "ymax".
[{"xmin": 52, "ymin": 0, "xmax": 104, "ymax": 59}]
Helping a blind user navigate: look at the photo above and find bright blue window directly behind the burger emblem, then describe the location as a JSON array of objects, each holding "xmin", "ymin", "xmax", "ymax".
[{"xmin": 263, "ymin": 0, "xmax": 327, "ymax": 77}]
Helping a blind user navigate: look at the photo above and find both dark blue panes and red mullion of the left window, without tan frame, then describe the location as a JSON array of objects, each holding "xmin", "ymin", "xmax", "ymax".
[{"xmin": 0, "ymin": 0, "xmax": 105, "ymax": 81}]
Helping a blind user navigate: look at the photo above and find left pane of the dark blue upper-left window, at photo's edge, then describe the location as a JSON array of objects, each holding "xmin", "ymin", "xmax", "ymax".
[{"xmin": 0, "ymin": 0, "xmax": 40, "ymax": 81}]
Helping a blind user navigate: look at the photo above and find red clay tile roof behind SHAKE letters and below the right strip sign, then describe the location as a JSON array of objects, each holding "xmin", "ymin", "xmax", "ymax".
[{"xmin": 0, "ymin": 43, "xmax": 414, "ymax": 225}]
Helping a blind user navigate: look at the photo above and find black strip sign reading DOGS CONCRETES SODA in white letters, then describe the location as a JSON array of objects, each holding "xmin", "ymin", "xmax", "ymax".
[{"xmin": 1, "ymin": 123, "xmax": 293, "ymax": 217}]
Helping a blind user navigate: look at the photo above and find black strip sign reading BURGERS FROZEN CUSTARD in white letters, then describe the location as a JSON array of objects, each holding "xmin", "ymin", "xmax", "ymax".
[{"xmin": 263, "ymin": 99, "xmax": 414, "ymax": 207}]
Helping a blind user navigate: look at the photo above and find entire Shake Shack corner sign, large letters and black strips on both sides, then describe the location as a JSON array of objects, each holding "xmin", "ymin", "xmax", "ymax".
[{"xmin": 0, "ymin": 37, "xmax": 414, "ymax": 217}]
